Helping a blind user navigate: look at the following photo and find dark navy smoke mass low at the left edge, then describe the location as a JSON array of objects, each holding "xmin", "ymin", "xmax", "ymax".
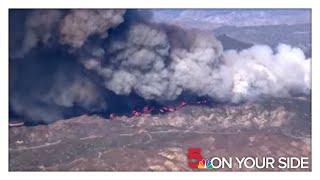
[{"xmin": 10, "ymin": 57, "xmax": 106, "ymax": 122}]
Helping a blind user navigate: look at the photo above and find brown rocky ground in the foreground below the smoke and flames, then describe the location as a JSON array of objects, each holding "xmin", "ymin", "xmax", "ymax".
[{"xmin": 9, "ymin": 98, "xmax": 311, "ymax": 171}]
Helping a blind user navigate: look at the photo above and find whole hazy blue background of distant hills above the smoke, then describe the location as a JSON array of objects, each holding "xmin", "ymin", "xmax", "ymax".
[{"xmin": 152, "ymin": 9, "xmax": 311, "ymax": 57}]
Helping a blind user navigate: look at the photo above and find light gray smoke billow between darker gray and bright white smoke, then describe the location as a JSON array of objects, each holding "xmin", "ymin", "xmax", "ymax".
[{"xmin": 169, "ymin": 33, "xmax": 226, "ymax": 99}]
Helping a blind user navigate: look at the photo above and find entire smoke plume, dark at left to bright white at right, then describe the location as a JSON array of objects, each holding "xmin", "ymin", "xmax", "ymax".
[{"xmin": 10, "ymin": 9, "xmax": 310, "ymax": 121}]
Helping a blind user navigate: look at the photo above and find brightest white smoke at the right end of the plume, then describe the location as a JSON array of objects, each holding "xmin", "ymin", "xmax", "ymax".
[{"xmin": 224, "ymin": 44, "xmax": 310, "ymax": 102}]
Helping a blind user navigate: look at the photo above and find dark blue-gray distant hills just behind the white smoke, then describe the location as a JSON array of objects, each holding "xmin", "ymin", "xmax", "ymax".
[{"xmin": 214, "ymin": 24, "xmax": 311, "ymax": 57}]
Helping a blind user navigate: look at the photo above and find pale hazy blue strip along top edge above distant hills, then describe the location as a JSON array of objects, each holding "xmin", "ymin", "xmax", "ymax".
[{"xmin": 153, "ymin": 9, "xmax": 311, "ymax": 29}]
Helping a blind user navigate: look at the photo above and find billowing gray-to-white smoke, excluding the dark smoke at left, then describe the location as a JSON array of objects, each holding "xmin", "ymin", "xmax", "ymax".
[{"xmin": 82, "ymin": 24, "xmax": 310, "ymax": 103}]
